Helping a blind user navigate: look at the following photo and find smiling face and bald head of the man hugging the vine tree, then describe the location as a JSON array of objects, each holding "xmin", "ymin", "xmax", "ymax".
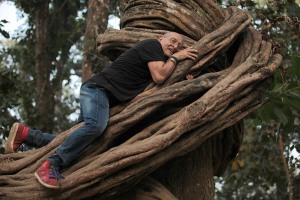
[{"xmin": 158, "ymin": 32, "xmax": 182, "ymax": 57}]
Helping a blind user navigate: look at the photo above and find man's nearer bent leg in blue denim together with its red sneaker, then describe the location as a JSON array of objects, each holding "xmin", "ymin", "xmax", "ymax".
[{"xmin": 35, "ymin": 84, "xmax": 109, "ymax": 189}]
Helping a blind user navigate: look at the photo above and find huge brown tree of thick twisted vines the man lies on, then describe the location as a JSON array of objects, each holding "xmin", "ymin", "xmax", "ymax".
[{"xmin": 0, "ymin": 0, "xmax": 281, "ymax": 199}]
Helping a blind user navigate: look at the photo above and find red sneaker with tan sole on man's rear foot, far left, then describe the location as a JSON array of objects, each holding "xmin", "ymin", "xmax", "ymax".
[{"xmin": 5, "ymin": 122, "xmax": 29, "ymax": 153}]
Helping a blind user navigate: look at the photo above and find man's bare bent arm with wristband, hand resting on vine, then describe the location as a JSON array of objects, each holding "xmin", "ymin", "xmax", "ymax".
[{"xmin": 148, "ymin": 47, "xmax": 198, "ymax": 84}]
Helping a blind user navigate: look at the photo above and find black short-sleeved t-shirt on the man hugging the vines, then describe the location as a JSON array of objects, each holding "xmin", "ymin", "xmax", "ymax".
[{"xmin": 87, "ymin": 39, "xmax": 166, "ymax": 102}]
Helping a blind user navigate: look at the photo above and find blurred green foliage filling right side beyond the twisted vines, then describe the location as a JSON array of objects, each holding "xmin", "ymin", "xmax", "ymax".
[{"xmin": 216, "ymin": 0, "xmax": 300, "ymax": 199}]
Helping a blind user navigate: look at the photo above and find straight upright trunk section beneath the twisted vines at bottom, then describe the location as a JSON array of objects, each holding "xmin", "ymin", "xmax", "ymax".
[{"xmin": 153, "ymin": 140, "xmax": 215, "ymax": 200}]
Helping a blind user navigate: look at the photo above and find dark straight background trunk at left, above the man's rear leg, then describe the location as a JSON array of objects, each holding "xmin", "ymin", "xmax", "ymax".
[{"xmin": 35, "ymin": 0, "xmax": 54, "ymax": 131}]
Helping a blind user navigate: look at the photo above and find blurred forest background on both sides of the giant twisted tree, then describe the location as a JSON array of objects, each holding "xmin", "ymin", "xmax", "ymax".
[{"xmin": 0, "ymin": 0, "xmax": 300, "ymax": 200}]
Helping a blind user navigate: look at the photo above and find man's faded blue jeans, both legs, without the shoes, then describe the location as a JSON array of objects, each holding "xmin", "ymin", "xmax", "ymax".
[{"xmin": 27, "ymin": 83, "xmax": 109, "ymax": 167}]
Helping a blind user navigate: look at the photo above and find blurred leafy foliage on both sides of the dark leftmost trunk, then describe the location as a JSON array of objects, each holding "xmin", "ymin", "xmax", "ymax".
[{"xmin": 0, "ymin": 0, "xmax": 87, "ymax": 141}]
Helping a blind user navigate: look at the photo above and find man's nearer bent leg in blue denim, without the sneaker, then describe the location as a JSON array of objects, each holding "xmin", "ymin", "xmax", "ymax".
[{"xmin": 49, "ymin": 84, "xmax": 109, "ymax": 166}]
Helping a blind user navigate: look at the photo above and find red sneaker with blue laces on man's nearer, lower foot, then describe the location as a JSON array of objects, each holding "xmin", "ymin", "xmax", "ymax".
[{"xmin": 34, "ymin": 160, "xmax": 64, "ymax": 189}]
